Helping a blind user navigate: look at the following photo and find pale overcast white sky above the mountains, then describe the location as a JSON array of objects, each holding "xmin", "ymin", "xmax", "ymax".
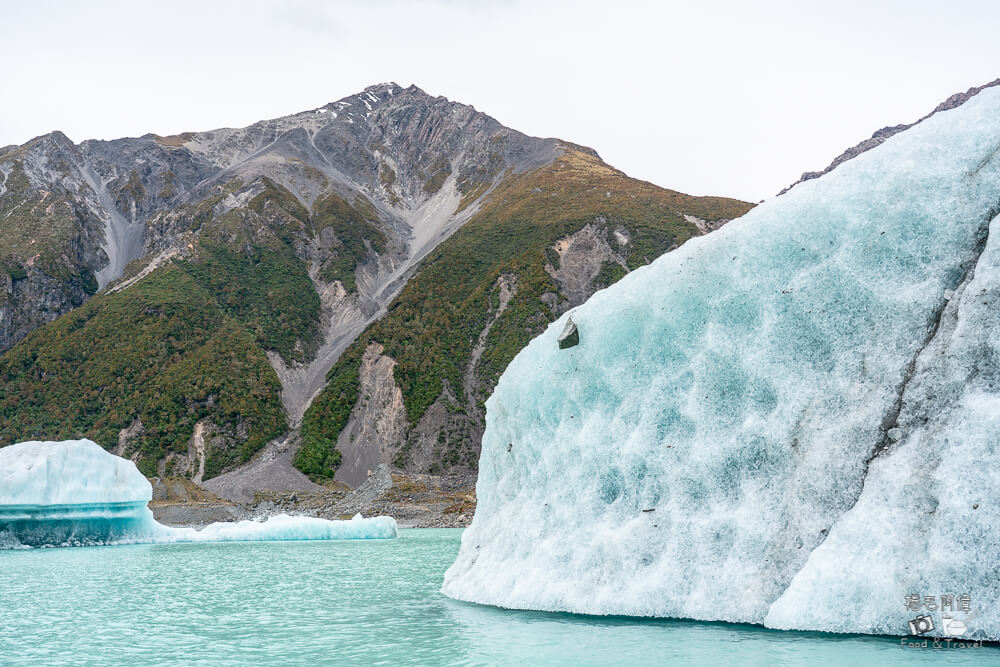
[{"xmin": 0, "ymin": 0, "xmax": 1000, "ymax": 201}]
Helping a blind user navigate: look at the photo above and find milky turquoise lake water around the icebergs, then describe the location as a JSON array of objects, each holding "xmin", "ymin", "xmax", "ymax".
[{"xmin": 0, "ymin": 530, "xmax": 1000, "ymax": 666}]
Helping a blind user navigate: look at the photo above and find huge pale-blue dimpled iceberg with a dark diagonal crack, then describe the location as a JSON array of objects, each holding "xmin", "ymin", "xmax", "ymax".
[{"xmin": 443, "ymin": 90, "xmax": 1000, "ymax": 639}]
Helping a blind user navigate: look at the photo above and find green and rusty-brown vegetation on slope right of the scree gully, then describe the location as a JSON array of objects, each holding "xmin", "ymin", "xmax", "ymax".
[{"xmin": 295, "ymin": 151, "xmax": 751, "ymax": 476}]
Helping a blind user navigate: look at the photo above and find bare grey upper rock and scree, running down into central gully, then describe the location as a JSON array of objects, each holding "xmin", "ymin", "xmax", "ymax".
[{"xmin": 0, "ymin": 83, "xmax": 562, "ymax": 360}]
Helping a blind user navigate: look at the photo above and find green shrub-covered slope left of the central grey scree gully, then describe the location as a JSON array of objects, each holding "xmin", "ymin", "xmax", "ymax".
[{"xmin": 0, "ymin": 179, "xmax": 377, "ymax": 480}]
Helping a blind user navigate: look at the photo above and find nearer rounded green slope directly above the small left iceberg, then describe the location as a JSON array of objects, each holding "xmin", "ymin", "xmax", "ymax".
[{"xmin": 0, "ymin": 266, "xmax": 285, "ymax": 477}]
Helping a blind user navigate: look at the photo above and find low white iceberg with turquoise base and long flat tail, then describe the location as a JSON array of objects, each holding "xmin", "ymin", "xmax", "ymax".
[{"xmin": 0, "ymin": 440, "xmax": 397, "ymax": 549}]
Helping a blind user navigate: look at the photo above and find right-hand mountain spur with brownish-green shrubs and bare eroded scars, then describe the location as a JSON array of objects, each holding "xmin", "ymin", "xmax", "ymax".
[{"xmin": 296, "ymin": 150, "xmax": 751, "ymax": 482}]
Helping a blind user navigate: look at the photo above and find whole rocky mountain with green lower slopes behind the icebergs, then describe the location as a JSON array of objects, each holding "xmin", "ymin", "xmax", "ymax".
[{"xmin": 0, "ymin": 84, "xmax": 750, "ymax": 497}]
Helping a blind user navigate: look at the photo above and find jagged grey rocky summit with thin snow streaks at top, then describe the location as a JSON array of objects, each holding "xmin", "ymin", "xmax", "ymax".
[{"xmin": 148, "ymin": 82, "xmax": 576, "ymax": 220}]
